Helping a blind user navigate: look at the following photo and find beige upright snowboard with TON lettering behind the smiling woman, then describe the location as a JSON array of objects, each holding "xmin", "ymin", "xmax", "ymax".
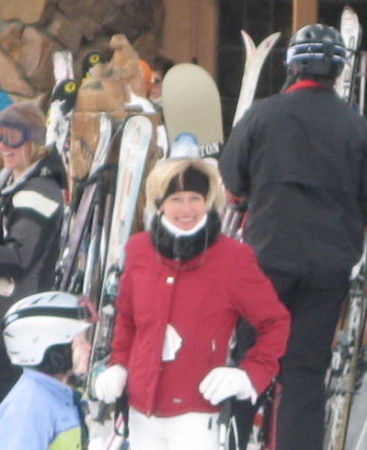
[{"xmin": 162, "ymin": 63, "xmax": 223, "ymax": 157}]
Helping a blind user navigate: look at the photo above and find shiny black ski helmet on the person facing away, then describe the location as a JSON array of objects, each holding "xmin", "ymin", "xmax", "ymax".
[{"xmin": 286, "ymin": 23, "xmax": 346, "ymax": 79}]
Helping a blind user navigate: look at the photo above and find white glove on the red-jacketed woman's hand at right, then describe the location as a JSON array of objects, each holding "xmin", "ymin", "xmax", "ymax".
[{"xmin": 199, "ymin": 367, "xmax": 257, "ymax": 405}]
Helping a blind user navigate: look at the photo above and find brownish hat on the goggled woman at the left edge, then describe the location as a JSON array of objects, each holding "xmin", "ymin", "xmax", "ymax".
[{"xmin": 0, "ymin": 101, "xmax": 46, "ymax": 145}]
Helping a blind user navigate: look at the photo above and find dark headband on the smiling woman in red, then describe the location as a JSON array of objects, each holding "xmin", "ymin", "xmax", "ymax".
[{"xmin": 161, "ymin": 166, "xmax": 209, "ymax": 203}]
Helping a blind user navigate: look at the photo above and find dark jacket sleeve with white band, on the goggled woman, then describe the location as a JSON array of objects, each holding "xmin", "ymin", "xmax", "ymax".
[{"xmin": 0, "ymin": 184, "xmax": 62, "ymax": 277}]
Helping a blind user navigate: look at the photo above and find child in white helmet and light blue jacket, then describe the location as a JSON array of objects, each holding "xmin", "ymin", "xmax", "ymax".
[{"xmin": 0, "ymin": 291, "xmax": 97, "ymax": 450}]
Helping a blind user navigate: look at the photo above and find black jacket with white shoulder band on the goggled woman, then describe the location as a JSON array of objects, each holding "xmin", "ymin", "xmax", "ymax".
[{"xmin": 0, "ymin": 148, "xmax": 66, "ymax": 318}]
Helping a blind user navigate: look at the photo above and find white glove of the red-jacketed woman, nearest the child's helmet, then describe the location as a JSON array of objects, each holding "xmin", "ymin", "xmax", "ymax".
[{"xmin": 94, "ymin": 364, "xmax": 127, "ymax": 403}]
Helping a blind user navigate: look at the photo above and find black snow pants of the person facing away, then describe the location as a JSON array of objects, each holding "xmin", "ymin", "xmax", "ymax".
[{"xmin": 263, "ymin": 267, "xmax": 349, "ymax": 450}]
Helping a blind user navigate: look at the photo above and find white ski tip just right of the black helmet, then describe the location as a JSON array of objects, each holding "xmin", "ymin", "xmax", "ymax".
[{"xmin": 335, "ymin": 6, "xmax": 362, "ymax": 102}]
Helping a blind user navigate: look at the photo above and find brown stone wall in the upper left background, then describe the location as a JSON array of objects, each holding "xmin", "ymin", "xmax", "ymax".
[{"xmin": 0, "ymin": 0, "xmax": 164, "ymax": 106}]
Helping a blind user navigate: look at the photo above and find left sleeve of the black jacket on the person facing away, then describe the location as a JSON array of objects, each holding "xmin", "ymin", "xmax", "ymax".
[{"xmin": 218, "ymin": 107, "xmax": 254, "ymax": 197}]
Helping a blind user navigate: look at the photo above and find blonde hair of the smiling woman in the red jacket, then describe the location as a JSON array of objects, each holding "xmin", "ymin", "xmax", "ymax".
[{"xmin": 145, "ymin": 158, "xmax": 225, "ymax": 211}]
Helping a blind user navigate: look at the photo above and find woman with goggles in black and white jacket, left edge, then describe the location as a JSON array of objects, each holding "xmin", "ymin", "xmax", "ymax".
[{"xmin": 0, "ymin": 102, "xmax": 66, "ymax": 401}]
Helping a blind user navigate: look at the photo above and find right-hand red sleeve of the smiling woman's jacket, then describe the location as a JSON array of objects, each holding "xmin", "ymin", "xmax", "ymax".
[{"xmin": 230, "ymin": 245, "xmax": 290, "ymax": 394}]
